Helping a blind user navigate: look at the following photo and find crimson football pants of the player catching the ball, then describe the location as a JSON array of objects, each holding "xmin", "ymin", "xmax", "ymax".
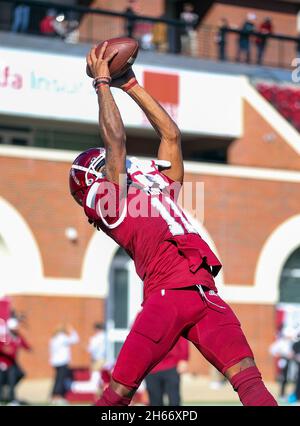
[{"xmin": 112, "ymin": 286, "xmax": 253, "ymax": 388}]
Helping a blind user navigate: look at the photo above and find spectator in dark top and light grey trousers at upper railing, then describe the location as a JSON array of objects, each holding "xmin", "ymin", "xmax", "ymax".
[{"xmin": 180, "ymin": 3, "xmax": 199, "ymax": 56}]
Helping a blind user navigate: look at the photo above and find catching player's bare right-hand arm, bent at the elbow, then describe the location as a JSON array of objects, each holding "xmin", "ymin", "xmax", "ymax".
[{"xmin": 112, "ymin": 70, "xmax": 184, "ymax": 183}]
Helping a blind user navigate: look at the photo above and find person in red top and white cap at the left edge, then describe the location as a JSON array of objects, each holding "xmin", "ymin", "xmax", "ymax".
[{"xmin": 0, "ymin": 318, "xmax": 31, "ymax": 405}]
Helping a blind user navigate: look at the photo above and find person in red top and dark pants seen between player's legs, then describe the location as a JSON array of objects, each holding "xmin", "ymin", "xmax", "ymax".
[{"xmin": 146, "ymin": 337, "xmax": 189, "ymax": 406}]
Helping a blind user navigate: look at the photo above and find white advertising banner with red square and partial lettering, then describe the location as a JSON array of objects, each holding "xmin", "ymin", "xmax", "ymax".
[{"xmin": 0, "ymin": 48, "xmax": 243, "ymax": 137}]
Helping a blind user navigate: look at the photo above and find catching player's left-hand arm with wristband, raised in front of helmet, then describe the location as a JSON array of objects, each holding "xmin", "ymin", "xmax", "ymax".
[{"xmin": 87, "ymin": 43, "xmax": 126, "ymax": 183}]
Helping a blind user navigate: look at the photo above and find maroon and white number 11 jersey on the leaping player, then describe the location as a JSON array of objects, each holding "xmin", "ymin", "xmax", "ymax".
[{"xmin": 83, "ymin": 161, "xmax": 221, "ymax": 298}]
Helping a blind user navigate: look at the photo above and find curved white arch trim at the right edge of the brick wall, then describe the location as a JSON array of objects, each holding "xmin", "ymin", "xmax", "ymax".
[{"xmin": 255, "ymin": 215, "xmax": 300, "ymax": 303}]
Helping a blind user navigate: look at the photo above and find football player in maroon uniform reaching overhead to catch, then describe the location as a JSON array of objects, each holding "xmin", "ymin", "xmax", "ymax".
[{"xmin": 70, "ymin": 43, "xmax": 277, "ymax": 406}]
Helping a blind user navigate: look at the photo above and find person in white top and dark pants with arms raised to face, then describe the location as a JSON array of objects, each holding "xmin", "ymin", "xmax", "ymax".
[{"xmin": 49, "ymin": 325, "xmax": 79, "ymax": 404}]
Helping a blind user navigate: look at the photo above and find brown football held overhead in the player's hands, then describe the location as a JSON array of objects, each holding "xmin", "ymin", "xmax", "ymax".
[{"xmin": 86, "ymin": 37, "xmax": 139, "ymax": 78}]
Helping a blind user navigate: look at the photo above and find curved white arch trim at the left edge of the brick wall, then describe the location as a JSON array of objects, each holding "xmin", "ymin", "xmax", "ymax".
[{"xmin": 0, "ymin": 197, "xmax": 43, "ymax": 294}]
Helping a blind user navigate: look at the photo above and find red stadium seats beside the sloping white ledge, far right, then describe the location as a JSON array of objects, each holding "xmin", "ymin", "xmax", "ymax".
[{"xmin": 256, "ymin": 83, "xmax": 300, "ymax": 131}]
